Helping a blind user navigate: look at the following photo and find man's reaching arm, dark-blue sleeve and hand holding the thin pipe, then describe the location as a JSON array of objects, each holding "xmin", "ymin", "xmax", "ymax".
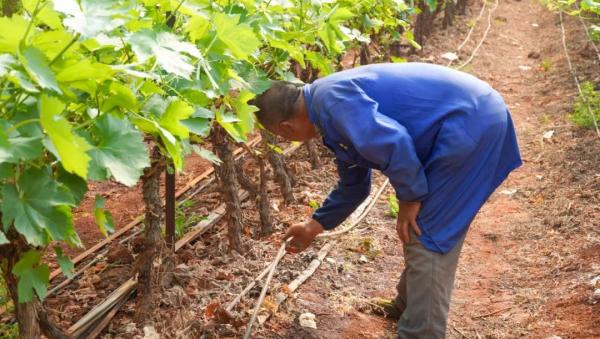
[{"xmin": 284, "ymin": 160, "xmax": 371, "ymax": 253}]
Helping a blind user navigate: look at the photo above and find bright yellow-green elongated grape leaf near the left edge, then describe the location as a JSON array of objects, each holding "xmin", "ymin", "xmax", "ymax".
[{"xmin": 38, "ymin": 94, "xmax": 92, "ymax": 179}]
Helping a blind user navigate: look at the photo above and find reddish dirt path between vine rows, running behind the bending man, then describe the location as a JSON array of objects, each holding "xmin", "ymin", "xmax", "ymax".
[{"xmin": 267, "ymin": 1, "xmax": 600, "ymax": 338}]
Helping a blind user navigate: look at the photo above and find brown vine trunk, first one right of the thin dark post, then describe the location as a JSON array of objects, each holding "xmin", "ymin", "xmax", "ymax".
[{"xmin": 211, "ymin": 124, "xmax": 243, "ymax": 253}]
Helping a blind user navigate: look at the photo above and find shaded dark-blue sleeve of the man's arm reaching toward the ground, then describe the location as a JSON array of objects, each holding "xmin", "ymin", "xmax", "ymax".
[{"xmin": 312, "ymin": 160, "xmax": 371, "ymax": 230}]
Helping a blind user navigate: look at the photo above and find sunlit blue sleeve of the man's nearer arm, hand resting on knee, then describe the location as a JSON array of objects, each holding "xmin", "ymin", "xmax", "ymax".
[{"xmin": 328, "ymin": 86, "xmax": 429, "ymax": 201}]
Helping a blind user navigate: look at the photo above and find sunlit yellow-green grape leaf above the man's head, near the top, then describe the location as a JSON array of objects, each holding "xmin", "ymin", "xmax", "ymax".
[{"xmin": 212, "ymin": 13, "xmax": 260, "ymax": 60}]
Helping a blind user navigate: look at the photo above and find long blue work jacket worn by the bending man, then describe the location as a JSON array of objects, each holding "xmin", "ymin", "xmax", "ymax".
[{"xmin": 304, "ymin": 63, "xmax": 521, "ymax": 253}]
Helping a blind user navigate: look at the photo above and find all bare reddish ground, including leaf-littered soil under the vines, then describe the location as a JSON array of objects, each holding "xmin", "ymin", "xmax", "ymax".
[{"xmin": 56, "ymin": 0, "xmax": 600, "ymax": 339}]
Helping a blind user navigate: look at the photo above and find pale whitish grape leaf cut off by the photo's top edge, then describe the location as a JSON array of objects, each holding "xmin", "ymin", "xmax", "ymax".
[{"xmin": 54, "ymin": 0, "xmax": 127, "ymax": 38}]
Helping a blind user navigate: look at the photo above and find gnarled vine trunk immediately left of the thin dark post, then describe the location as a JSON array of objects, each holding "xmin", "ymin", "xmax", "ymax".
[{"xmin": 135, "ymin": 146, "xmax": 166, "ymax": 324}]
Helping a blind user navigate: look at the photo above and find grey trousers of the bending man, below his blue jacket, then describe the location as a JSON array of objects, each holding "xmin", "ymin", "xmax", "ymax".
[{"xmin": 395, "ymin": 232, "xmax": 466, "ymax": 339}]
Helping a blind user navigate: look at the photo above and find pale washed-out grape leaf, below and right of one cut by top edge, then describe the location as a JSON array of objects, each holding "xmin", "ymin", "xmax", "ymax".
[{"xmin": 128, "ymin": 29, "xmax": 200, "ymax": 79}]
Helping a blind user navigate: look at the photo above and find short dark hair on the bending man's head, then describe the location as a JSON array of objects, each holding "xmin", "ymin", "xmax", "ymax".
[{"xmin": 253, "ymin": 81, "xmax": 304, "ymax": 126}]
